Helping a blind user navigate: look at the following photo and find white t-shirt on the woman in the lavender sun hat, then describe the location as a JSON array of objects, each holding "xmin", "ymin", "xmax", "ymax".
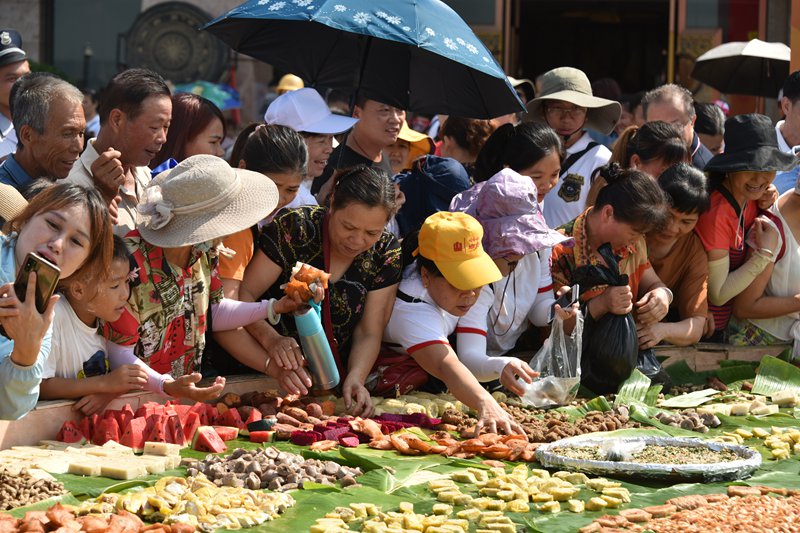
[{"xmin": 484, "ymin": 248, "xmax": 555, "ymax": 357}]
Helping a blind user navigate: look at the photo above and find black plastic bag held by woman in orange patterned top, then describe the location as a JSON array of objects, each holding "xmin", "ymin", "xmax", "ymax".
[{"xmin": 572, "ymin": 243, "xmax": 668, "ymax": 394}]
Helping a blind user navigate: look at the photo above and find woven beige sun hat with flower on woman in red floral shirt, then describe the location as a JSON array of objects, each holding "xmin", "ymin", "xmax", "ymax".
[{"xmin": 136, "ymin": 154, "xmax": 278, "ymax": 248}]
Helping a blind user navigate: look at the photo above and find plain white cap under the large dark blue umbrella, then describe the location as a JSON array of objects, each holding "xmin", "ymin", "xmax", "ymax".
[{"xmin": 264, "ymin": 87, "xmax": 358, "ymax": 135}]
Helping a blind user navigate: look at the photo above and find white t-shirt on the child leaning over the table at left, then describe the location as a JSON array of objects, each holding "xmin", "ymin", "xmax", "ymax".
[{"xmin": 42, "ymin": 295, "xmax": 108, "ymax": 379}]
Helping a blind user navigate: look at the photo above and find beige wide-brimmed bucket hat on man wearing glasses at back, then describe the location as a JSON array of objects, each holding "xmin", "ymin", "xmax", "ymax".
[{"xmin": 525, "ymin": 67, "xmax": 622, "ymax": 135}]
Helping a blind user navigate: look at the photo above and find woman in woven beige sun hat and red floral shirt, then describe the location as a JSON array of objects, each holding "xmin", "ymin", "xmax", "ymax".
[{"xmin": 106, "ymin": 155, "xmax": 321, "ymax": 392}]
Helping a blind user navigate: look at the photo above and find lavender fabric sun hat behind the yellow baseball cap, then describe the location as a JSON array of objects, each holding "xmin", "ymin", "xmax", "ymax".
[{"xmin": 450, "ymin": 168, "xmax": 569, "ymax": 259}]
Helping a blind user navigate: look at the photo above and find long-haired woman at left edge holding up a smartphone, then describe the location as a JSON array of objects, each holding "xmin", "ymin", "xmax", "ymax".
[{"xmin": 0, "ymin": 182, "xmax": 112, "ymax": 419}]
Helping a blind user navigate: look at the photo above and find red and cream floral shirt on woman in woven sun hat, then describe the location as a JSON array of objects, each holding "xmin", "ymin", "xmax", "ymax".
[{"xmin": 104, "ymin": 230, "xmax": 222, "ymax": 377}]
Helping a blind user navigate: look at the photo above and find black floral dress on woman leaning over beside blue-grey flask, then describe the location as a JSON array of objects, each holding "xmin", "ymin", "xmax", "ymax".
[{"xmin": 258, "ymin": 206, "xmax": 402, "ymax": 367}]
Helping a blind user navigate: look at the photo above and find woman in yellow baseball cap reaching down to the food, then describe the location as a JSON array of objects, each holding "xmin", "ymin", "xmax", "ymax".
[{"xmin": 374, "ymin": 212, "xmax": 523, "ymax": 433}]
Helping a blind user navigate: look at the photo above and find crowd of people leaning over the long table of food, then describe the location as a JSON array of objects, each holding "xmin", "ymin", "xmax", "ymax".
[{"xmin": 0, "ymin": 26, "xmax": 800, "ymax": 432}]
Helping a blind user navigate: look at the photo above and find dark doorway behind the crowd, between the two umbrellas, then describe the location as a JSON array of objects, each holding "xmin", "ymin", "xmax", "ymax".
[{"xmin": 518, "ymin": 0, "xmax": 669, "ymax": 93}]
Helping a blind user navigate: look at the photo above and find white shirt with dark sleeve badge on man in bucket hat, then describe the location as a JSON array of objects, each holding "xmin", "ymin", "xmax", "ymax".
[{"xmin": 543, "ymin": 132, "xmax": 611, "ymax": 228}]
